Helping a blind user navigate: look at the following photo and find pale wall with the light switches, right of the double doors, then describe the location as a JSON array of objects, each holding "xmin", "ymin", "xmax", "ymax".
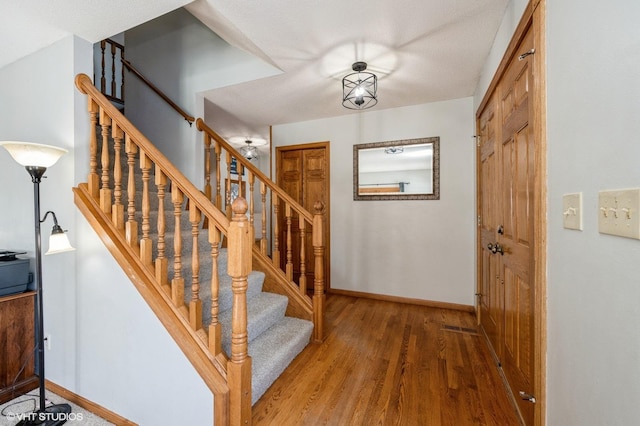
[{"xmin": 547, "ymin": 0, "xmax": 640, "ymax": 425}]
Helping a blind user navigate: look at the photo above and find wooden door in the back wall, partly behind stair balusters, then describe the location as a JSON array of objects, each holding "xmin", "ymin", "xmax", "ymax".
[{"xmin": 276, "ymin": 142, "xmax": 330, "ymax": 291}]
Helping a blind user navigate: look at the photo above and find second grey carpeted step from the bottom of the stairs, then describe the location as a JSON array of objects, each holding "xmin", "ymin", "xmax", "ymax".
[{"xmin": 218, "ymin": 292, "xmax": 289, "ymax": 354}]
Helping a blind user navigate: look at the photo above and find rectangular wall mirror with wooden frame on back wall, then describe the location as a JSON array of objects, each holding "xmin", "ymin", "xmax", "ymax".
[{"xmin": 353, "ymin": 137, "xmax": 440, "ymax": 201}]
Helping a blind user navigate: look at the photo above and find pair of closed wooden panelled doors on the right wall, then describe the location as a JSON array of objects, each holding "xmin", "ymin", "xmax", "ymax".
[{"xmin": 477, "ymin": 2, "xmax": 544, "ymax": 425}]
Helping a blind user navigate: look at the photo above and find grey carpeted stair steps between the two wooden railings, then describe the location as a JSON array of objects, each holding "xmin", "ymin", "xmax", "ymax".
[{"xmin": 138, "ymin": 155, "xmax": 313, "ymax": 405}]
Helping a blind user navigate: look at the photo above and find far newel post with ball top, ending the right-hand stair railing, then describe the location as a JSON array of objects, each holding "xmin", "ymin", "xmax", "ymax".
[{"xmin": 312, "ymin": 201, "xmax": 325, "ymax": 343}]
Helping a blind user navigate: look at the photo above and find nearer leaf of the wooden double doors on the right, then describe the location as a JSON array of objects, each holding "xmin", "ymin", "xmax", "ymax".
[{"xmin": 498, "ymin": 31, "xmax": 536, "ymax": 424}]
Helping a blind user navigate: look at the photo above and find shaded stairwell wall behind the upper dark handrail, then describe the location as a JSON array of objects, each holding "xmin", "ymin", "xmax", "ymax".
[{"xmin": 125, "ymin": 9, "xmax": 280, "ymax": 188}]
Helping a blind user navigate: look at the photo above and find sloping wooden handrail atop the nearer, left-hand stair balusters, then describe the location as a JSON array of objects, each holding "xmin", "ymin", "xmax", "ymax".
[{"xmin": 75, "ymin": 74, "xmax": 229, "ymax": 229}]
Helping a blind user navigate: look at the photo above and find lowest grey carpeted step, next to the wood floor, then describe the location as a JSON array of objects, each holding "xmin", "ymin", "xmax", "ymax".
[{"xmin": 249, "ymin": 317, "xmax": 313, "ymax": 405}]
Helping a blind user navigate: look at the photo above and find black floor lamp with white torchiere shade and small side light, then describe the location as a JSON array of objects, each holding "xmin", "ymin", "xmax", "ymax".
[{"xmin": 0, "ymin": 141, "xmax": 74, "ymax": 426}]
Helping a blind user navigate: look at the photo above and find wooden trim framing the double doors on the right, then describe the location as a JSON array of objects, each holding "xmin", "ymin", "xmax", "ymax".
[{"xmin": 476, "ymin": 0, "xmax": 547, "ymax": 426}]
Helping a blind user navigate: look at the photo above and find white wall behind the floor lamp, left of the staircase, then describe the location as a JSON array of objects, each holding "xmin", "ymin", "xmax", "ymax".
[{"xmin": 0, "ymin": 37, "xmax": 84, "ymax": 390}]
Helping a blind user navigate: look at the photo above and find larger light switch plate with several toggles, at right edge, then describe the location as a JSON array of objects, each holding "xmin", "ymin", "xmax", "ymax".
[{"xmin": 598, "ymin": 188, "xmax": 640, "ymax": 240}]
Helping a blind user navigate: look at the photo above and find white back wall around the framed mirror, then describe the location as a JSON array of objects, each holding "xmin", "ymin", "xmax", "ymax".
[{"xmin": 273, "ymin": 98, "xmax": 475, "ymax": 305}]
